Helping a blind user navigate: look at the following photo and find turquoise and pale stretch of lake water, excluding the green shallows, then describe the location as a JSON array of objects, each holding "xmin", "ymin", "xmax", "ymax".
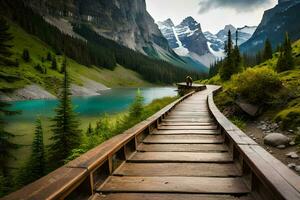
[{"xmin": 8, "ymin": 87, "xmax": 177, "ymax": 122}]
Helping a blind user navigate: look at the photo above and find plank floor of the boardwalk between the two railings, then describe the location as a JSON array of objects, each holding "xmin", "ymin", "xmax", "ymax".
[{"xmin": 94, "ymin": 90, "xmax": 250, "ymax": 200}]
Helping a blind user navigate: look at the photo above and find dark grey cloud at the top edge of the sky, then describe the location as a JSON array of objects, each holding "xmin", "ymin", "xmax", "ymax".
[{"xmin": 199, "ymin": 0, "xmax": 272, "ymax": 13}]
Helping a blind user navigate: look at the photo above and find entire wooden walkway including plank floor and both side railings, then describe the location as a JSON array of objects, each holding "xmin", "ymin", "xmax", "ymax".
[{"xmin": 3, "ymin": 85, "xmax": 300, "ymax": 200}]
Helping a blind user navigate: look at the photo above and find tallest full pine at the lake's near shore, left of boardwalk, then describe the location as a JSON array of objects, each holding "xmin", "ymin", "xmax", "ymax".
[{"xmin": 49, "ymin": 58, "xmax": 81, "ymax": 167}]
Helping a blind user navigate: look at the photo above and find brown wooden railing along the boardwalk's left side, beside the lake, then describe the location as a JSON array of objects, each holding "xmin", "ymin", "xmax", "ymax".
[{"xmin": 4, "ymin": 87, "xmax": 202, "ymax": 200}]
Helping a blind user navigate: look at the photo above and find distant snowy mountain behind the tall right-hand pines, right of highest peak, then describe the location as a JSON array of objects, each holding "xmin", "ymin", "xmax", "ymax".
[{"xmin": 204, "ymin": 24, "xmax": 257, "ymax": 58}]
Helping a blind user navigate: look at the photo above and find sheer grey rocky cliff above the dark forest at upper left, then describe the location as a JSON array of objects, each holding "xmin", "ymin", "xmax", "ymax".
[{"xmin": 24, "ymin": 0, "xmax": 176, "ymax": 59}]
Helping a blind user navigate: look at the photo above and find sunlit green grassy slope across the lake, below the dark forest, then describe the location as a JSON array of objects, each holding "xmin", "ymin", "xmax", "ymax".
[{"xmin": 0, "ymin": 22, "xmax": 150, "ymax": 94}]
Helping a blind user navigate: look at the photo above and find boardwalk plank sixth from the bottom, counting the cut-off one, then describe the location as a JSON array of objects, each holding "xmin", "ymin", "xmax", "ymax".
[{"xmin": 143, "ymin": 135, "xmax": 224, "ymax": 144}]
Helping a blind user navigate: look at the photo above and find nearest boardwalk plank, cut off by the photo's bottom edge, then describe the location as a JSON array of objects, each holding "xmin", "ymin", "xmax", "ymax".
[{"xmin": 91, "ymin": 193, "xmax": 253, "ymax": 200}]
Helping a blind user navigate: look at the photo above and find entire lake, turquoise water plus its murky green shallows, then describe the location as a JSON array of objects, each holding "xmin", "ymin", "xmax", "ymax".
[{"xmin": 7, "ymin": 87, "xmax": 177, "ymax": 168}]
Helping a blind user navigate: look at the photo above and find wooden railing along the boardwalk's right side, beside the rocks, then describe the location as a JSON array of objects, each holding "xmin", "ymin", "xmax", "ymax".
[{"xmin": 208, "ymin": 88, "xmax": 300, "ymax": 200}]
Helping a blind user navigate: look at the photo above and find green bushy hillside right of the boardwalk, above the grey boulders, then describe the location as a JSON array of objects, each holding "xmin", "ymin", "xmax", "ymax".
[{"xmin": 200, "ymin": 40, "xmax": 300, "ymax": 130}]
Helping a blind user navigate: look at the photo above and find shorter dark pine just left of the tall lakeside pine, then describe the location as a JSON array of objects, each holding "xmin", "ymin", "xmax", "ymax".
[{"xmin": 20, "ymin": 118, "xmax": 46, "ymax": 185}]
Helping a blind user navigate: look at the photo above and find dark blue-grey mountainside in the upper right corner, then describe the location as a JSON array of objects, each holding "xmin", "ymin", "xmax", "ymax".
[{"xmin": 241, "ymin": 0, "xmax": 300, "ymax": 53}]
